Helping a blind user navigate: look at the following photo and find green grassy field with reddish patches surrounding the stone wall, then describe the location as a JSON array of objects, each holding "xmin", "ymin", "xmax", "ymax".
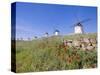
[{"xmin": 16, "ymin": 34, "xmax": 97, "ymax": 72}]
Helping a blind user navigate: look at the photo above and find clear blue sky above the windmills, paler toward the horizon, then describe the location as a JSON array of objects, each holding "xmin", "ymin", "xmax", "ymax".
[{"xmin": 16, "ymin": 2, "xmax": 97, "ymax": 38}]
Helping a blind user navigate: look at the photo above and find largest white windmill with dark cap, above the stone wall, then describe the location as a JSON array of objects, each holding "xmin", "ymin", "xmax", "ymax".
[{"xmin": 73, "ymin": 19, "xmax": 91, "ymax": 34}]
